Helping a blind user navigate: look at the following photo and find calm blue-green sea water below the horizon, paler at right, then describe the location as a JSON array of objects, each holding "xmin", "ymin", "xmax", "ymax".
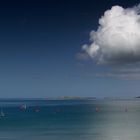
[{"xmin": 0, "ymin": 100, "xmax": 140, "ymax": 140}]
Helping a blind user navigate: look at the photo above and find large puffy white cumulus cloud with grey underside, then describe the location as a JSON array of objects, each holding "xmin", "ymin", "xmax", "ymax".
[{"xmin": 82, "ymin": 6, "xmax": 140, "ymax": 64}]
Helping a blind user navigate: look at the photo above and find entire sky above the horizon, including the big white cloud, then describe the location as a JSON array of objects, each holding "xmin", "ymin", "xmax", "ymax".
[{"xmin": 0, "ymin": 0, "xmax": 140, "ymax": 98}]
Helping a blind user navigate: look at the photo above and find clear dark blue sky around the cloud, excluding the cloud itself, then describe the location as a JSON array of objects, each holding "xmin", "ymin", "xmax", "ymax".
[{"xmin": 0, "ymin": 0, "xmax": 140, "ymax": 98}]
